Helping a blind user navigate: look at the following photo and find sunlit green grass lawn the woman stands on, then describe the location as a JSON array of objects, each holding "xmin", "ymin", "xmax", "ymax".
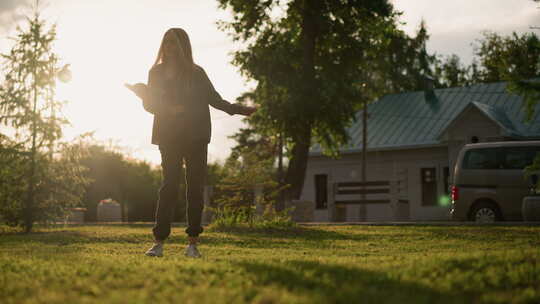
[{"xmin": 0, "ymin": 224, "xmax": 540, "ymax": 304}]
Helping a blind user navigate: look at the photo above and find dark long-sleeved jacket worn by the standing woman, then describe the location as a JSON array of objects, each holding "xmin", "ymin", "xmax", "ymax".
[{"xmin": 143, "ymin": 64, "xmax": 238, "ymax": 145}]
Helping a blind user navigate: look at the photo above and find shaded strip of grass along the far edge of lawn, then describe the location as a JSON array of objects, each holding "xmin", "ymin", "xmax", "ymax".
[{"xmin": 12, "ymin": 223, "xmax": 540, "ymax": 248}]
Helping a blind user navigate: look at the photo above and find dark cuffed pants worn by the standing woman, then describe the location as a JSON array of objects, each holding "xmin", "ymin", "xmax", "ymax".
[{"xmin": 152, "ymin": 142, "xmax": 207, "ymax": 241}]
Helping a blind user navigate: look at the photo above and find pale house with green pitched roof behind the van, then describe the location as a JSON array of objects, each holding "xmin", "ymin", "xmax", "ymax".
[{"xmin": 301, "ymin": 82, "xmax": 540, "ymax": 222}]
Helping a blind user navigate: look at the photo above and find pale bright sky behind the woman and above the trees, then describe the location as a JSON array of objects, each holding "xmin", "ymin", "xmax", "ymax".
[{"xmin": 0, "ymin": 0, "xmax": 540, "ymax": 164}]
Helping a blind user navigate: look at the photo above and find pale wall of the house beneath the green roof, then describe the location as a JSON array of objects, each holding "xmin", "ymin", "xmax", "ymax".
[{"xmin": 301, "ymin": 146, "xmax": 449, "ymax": 222}]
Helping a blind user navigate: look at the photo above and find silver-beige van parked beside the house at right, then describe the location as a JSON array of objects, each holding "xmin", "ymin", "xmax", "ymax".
[{"xmin": 451, "ymin": 141, "xmax": 540, "ymax": 222}]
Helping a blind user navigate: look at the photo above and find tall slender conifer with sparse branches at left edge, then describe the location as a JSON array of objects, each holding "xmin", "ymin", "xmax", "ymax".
[{"xmin": 0, "ymin": 10, "xmax": 82, "ymax": 232}]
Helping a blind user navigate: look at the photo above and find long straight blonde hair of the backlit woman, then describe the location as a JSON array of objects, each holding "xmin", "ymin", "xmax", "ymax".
[{"xmin": 152, "ymin": 27, "xmax": 195, "ymax": 84}]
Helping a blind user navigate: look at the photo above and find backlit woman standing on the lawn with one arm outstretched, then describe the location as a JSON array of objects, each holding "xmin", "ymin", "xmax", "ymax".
[{"xmin": 127, "ymin": 28, "xmax": 256, "ymax": 257}]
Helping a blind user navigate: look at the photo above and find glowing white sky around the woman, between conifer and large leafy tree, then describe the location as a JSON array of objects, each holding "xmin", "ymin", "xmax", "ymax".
[{"xmin": 32, "ymin": 0, "xmax": 247, "ymax": 164}]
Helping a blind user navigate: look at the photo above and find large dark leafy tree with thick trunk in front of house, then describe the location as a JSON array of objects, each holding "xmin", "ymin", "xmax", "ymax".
[{"xmin": 215, "ymin": 0, "xmax": 424, "ymax": 204}]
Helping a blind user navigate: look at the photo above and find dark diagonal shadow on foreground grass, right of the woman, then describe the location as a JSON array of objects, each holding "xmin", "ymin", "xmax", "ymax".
[{"xmin": 237, "ymin": 260, "xmax": 462, "ymax": 303}]
